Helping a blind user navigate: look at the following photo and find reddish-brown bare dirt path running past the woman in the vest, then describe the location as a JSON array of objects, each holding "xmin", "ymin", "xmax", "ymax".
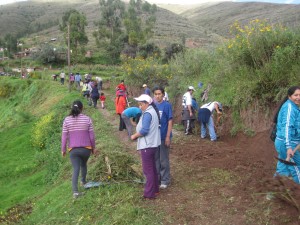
[{"xmin": 99, "ymin": 90, "xmax": 300, "ymax": 225}]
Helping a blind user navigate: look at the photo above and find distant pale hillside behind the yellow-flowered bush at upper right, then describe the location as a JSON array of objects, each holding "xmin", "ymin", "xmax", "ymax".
[{"xmin": 181, "ymin": 2, "xmax": 300, "ymax": 37}]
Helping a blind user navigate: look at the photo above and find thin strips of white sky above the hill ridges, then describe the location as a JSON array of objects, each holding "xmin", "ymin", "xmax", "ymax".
[{"xmin": 0, "ymin": 0, "xmax": 300, "ymax": 5}]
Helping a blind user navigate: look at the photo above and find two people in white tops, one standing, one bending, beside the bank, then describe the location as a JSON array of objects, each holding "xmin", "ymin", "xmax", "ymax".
[{"xmin": 182, "ymin": 86, "xmax": 223, "ymax": 141}]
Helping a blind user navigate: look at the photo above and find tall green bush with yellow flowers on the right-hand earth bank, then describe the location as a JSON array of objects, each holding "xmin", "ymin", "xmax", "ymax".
[{"xmin": 224, "ymin": 19, "xmax": 300, "ymax": 102}]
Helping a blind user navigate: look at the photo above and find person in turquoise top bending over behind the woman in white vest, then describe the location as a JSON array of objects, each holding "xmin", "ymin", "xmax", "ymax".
[{"xmin": 121, "ymin": 107, "xmax": 142, "ymax": 139}]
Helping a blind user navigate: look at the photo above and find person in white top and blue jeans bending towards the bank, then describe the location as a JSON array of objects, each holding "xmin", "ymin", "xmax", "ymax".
[{"xmin": 198, "ymin": 102, "xmax": 222, "ymax": 141}]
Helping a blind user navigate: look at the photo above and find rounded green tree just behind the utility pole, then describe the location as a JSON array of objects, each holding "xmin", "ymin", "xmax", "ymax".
[{"xmin": 60, "ymin": 9, "xmax": 88, "ymax": 59}]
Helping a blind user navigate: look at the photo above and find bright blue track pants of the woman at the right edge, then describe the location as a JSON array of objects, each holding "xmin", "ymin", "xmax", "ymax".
[{"xmin": 275, "ymin": 138, "xmax": 300, "ymax": 184}]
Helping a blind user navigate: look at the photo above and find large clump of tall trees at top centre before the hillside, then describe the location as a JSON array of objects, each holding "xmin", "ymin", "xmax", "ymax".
[{"xmin": 93, "ymin": 0, "xmax": 156, "ymax": 62}]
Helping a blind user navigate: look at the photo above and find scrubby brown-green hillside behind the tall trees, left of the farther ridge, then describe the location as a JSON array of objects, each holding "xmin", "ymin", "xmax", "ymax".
[{"xmin": 0, "ymin": 0, "xmax": 219, "ymax": 48}]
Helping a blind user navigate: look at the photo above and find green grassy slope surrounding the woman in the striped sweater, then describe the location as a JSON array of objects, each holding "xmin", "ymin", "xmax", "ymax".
[{"xmin": 0, "ymin": 79, "xmax": 160, "ymax": 224}]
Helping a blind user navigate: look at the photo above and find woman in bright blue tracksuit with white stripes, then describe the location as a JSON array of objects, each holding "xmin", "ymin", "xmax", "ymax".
[{"xmin": 274, "ymin": 86, "xmax": 300, "ymax": 184}]
